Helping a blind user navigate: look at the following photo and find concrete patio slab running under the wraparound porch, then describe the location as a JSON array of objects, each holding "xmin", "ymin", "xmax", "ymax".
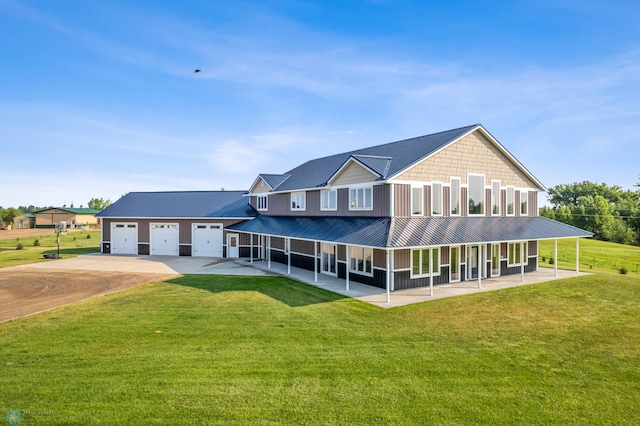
[{"xmin": 236, "ymin": 259, "xmax": 589, "ymax": 308}]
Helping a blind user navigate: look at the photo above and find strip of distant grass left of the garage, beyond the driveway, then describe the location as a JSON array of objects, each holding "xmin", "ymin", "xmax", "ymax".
[{"xmin": 0, "ymin": 229, "xmax": 100, "ymax": 268}]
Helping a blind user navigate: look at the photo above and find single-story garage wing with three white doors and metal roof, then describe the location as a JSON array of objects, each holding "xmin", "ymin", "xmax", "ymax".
[{"xmin": 97, "ymin": 191, "xmax": 257, "ymax": 258}]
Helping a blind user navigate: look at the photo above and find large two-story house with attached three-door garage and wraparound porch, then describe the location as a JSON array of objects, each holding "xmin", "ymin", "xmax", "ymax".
[{"xmin": 98, "ymin": 124, "xmax": 592, "ymax": 294}]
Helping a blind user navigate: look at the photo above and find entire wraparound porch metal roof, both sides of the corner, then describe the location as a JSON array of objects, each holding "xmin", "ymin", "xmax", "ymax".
[{"xmin": 229, "ymin": 216, "xmax": 593, "ymax": 248}]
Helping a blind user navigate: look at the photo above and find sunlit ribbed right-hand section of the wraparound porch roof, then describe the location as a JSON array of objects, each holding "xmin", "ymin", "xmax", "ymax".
[{"xmin": 389, "ymin": 216, "xmax": 593, "ymax": 247}]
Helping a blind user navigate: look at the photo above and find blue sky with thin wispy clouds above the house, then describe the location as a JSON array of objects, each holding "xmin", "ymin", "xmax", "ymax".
[{"xmin": 0, "ymin": 0, "xmax": 640, "ymax": 207}]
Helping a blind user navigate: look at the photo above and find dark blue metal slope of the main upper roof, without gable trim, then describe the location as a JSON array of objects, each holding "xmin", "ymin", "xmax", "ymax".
[{"xmin": 278, "ymin": 124, "xmax": 479, "ymax": 191}]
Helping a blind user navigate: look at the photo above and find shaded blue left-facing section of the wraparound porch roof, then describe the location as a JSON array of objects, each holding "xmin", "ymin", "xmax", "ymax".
[{"xmin": 228, "ymin": 216, "xmax": 391, "ymax": 247}]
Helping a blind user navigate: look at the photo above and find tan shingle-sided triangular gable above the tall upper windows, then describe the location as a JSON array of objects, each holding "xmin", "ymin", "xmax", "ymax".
[{"xmin": 393, "ymin": 128, "xmax": 545, "ymax": 190}]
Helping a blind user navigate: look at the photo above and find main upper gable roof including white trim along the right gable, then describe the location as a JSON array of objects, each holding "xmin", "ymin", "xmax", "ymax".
[{"xmin": 272, "ymin": 124, "xmax": 545, "ymax": 192}]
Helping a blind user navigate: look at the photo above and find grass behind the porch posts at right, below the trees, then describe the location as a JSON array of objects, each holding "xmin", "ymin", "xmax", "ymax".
[{"xmin": 538, "ymin": 238, "xmax": 640, "ymax": 274}]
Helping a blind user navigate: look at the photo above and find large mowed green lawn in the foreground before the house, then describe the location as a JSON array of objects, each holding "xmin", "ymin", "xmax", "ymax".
[{"xmin": 0, "ymin": 273, "xmax": 640, "ymax": 425}]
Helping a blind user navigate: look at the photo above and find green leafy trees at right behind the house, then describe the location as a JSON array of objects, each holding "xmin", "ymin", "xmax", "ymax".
[{"xmin": 539, "ymin": 181, "xmax": 640, "ymax": 245}]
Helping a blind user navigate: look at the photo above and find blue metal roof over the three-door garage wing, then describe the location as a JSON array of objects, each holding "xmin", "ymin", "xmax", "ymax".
[{"xmin": 96, "ymin": 191, "xmax": 257, "ymax": 219}]
